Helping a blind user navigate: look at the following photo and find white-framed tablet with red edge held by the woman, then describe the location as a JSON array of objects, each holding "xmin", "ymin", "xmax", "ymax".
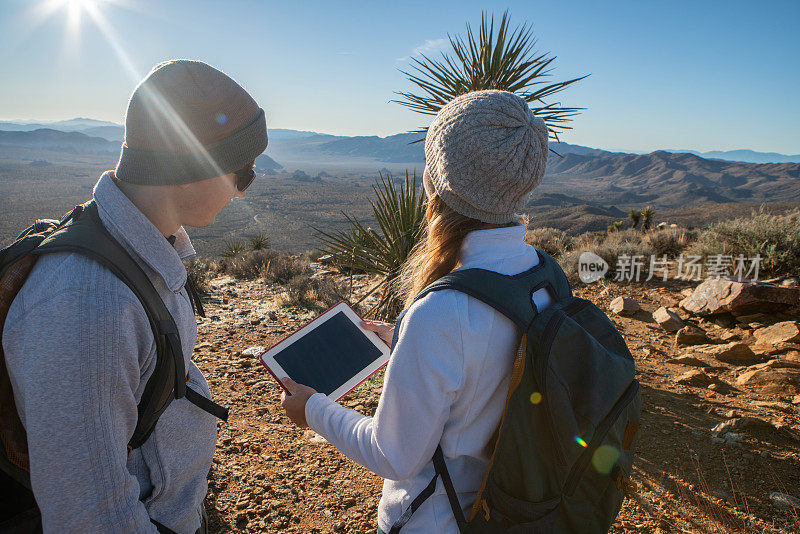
[{"xmin": 261, "ymin": 302, "xmax": 390, "ymax": 401}]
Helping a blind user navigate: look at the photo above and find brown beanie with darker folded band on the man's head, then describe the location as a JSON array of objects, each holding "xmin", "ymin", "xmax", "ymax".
[{"xmin": 116, "ymin": 59, "xmax": 267, "ymax": 185}]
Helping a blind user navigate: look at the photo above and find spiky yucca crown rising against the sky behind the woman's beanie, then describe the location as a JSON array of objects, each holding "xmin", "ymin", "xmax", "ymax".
[{"xmin": 394, "ymin": 11, "xmax": 586, "ymax": 140}]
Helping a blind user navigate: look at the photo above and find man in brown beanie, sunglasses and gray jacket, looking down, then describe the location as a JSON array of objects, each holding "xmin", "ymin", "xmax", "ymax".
[{"xmin": 3, "ymin": 60, "xmax": 267, "ymax": 534}]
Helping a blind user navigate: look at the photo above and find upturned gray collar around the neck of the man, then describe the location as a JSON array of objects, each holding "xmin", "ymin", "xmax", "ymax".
[{"xmin": 93, "ymin": 171, "xmax": 196, "ymax": 292}]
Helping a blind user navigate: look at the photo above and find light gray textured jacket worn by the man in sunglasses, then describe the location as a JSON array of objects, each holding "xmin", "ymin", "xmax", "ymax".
[{"xmin": 3, "ymin": 173, "xmax": 217, "ymax": 533}]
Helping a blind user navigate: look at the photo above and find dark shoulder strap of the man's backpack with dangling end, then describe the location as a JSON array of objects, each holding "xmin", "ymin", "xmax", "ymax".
[{"xmin": 33, "ymin": 201, "xmax": 227, "ymax": 449}]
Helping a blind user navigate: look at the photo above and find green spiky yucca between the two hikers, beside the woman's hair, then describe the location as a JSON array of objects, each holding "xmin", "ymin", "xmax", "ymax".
[{"xmin": 315, "ymin": 171, "xmax": 425, "ymax": 319}]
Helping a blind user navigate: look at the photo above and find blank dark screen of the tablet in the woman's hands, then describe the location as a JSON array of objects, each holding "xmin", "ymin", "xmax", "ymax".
[{"xmin": 274, "ymin": 312, "xmax": 381, "ymax": 395}]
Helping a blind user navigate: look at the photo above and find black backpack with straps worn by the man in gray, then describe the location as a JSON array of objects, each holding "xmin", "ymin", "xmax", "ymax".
[{"xmin": 0, "ymin": 201, "xmax": 228, "ymax": 533}]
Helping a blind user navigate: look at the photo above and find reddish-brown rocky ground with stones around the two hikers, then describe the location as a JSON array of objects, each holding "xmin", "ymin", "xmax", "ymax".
[{"xmin": 195, "ymin": 270, "xmax": 800, "ymax": 533}]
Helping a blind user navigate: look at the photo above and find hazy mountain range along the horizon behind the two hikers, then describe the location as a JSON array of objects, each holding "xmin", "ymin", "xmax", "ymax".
[{"xmin": 0, "ymin": 119, "xmax": 800, "ymax": 213}]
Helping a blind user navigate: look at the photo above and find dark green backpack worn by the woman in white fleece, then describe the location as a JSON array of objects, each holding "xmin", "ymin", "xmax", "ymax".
[{"xmin": 389, "ymin": 249, "xmax": 641, "ymax": 534}]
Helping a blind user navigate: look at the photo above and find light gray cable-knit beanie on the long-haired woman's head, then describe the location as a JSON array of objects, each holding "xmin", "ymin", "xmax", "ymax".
[{"xmin": 422, "ymin": 90, "xmax": 548, "ymax": 224}]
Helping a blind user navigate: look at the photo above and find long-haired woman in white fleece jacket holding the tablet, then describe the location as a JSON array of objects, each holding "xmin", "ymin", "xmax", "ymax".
[{"xmin": 281, "ymin": 91, "xmax": 549, "ymax": 534}]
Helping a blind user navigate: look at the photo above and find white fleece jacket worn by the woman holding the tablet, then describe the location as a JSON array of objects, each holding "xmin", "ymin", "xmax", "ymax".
[{"xmin": 306, "ymin": 225, "xmax": 549, "ymax": 534}]
